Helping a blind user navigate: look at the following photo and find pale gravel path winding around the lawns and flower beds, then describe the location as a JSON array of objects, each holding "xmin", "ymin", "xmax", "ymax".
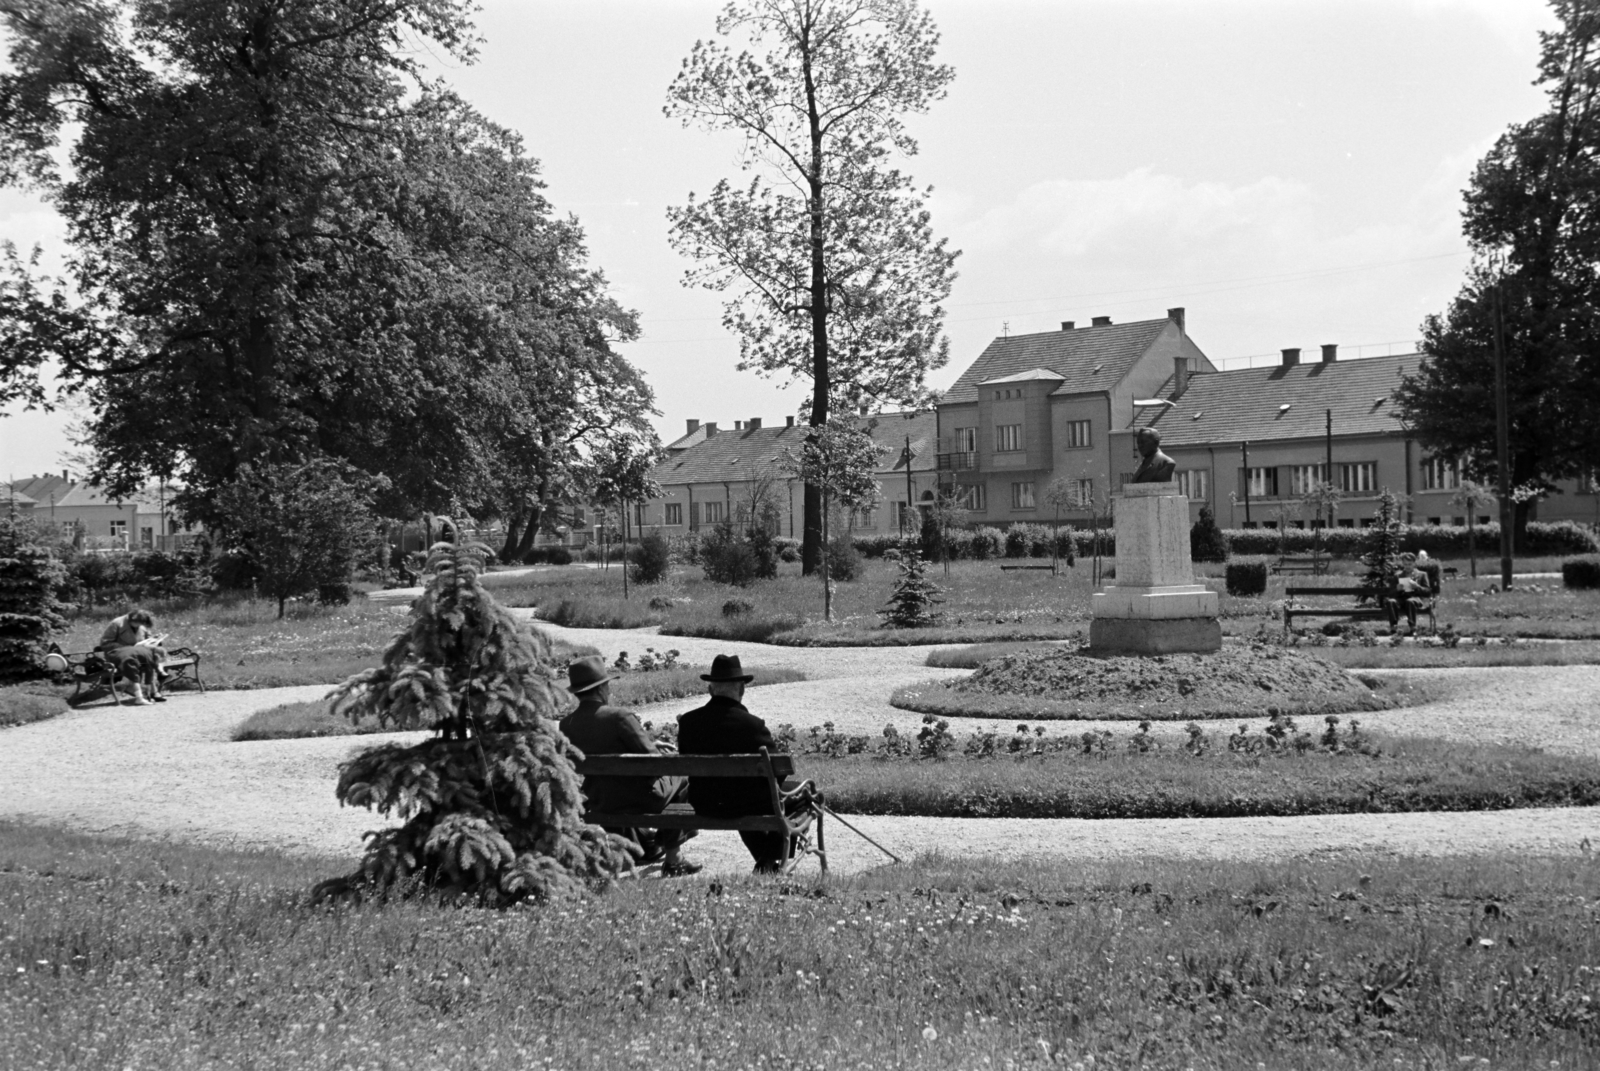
[{"xmin": 0, "ymin": 617, "xmax": 1600, "ymax": 872}]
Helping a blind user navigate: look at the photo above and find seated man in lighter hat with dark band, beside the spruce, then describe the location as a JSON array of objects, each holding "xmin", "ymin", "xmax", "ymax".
[{"xmin": 562, "ymin": 655, "xmax": 701, "ymax": 877}]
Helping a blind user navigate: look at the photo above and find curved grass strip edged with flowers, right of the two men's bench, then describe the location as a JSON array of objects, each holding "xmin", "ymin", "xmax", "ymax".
[{"xmin": 797, "ymin": 727, "xmax": 1600, "ymax": 818}]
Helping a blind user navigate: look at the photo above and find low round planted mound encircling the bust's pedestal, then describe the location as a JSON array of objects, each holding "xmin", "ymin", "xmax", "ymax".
[{"xmin": 893, "ymin": 644, "xmax": 1419, "ymax": 720}]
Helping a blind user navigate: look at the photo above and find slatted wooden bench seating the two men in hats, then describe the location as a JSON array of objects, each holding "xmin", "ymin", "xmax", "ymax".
[{"xmin": 576, "ymin": 748, "xmax": 827, "ymax": 874}]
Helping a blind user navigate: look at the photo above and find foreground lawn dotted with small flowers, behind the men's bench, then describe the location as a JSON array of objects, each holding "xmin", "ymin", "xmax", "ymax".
[{"xmin": 0, "ymin": 824, "xmax": 1600, "ymax": 1071}]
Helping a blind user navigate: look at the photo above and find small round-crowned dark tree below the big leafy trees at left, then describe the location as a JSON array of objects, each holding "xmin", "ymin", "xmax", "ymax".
[{"xmin": 216, "ymin": 458, "xmax": 381, "ymax": 618}]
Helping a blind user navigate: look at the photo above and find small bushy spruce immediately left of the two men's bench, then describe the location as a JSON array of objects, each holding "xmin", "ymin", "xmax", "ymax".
[{"xmin": 314, "ymin": 544, "xmax": 629, "ymax": 905}]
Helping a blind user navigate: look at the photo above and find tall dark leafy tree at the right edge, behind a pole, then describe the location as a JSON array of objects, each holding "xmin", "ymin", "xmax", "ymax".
[{"xmin": 1397, "ymin": 0, "xmax": 1600, "ymax": 543}]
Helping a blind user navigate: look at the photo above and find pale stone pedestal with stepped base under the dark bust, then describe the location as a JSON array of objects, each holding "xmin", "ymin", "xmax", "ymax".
[{"xmin": 1090, "ymin": 483, "xmax": 1222, "ymax": 655}]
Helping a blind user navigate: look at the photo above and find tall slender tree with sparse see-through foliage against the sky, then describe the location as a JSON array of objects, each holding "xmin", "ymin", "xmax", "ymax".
[{"xmin": 666, "ymin": 0, "xmax": 957, "ymax": 573}]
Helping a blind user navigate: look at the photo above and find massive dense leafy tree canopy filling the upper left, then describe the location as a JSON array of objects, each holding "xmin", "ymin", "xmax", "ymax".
[{"xmin": 0, "ymin": 0, "xmax": 650, "ymax": 531}]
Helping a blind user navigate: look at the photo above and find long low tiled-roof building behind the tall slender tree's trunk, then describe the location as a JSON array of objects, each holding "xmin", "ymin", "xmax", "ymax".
[{"xmin": 634, "ymin": 413, "xmax": 938, "ymax": 538}]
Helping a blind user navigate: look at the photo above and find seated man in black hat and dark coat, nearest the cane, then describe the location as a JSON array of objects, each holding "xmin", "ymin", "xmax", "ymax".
[{"xmin": 678, "ymin": 655, "xmax": 789, "ymax": 874}]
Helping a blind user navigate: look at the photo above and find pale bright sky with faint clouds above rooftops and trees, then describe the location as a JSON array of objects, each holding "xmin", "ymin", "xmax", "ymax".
[{"xmin": 0, "ymin": 0, "xmax": 1555, "ymax": 479}]
